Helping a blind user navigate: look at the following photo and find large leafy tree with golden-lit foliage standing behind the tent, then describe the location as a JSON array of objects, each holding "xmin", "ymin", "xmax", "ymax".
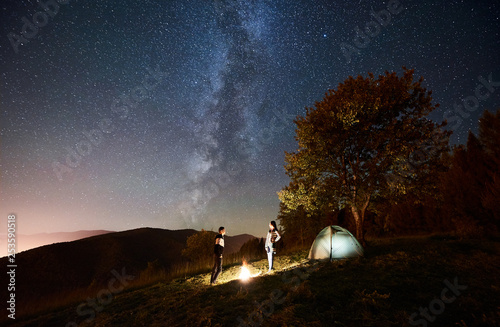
[{"xmin": 278, "ymin": 68, "xmax": 449, "ymax": 242}]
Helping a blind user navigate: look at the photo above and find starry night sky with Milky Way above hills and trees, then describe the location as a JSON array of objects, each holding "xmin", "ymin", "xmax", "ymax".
[{"xmin": 0, "ymin": 0, "xmax": 500, "ymax": 240}]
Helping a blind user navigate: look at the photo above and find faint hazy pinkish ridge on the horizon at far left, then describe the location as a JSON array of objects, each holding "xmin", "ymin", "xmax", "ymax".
[{"xmin": 0, "ymin": 230, "xmax": 114, "ymax": 257}]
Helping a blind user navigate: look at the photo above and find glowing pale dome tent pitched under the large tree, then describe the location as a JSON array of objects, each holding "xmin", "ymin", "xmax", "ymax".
[{"xmin": 308, "ymin": 225, "xmax": 363, "ymax": 260}]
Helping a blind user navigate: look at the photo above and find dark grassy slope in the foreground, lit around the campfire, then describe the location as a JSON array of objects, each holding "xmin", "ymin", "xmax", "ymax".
[{"xmin": 6, "ymin": 237, "xmax": 500, "ymax": 327}]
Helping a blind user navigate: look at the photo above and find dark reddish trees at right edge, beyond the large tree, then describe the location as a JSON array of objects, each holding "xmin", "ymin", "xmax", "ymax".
[{"xmin": 374, "ymin": 111, "xmax": 500, "ymax": 237}]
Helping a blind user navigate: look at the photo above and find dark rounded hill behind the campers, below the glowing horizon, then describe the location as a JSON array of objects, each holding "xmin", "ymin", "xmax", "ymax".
[{"xmin": 0, "ymin": 228, "xmax": 254, "ymax": 303}]
